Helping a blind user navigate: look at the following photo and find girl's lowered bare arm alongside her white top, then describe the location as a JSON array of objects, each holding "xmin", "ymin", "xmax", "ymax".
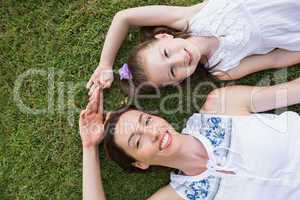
[{"xmin": 216, "ymin": 49, "xmax": 300, "ymax": 80}]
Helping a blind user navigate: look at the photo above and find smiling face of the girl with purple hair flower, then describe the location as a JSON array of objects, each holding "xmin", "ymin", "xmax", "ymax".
[{"xmin": 141, "ymin": 34, "xmax": 201, "ymax": 86}]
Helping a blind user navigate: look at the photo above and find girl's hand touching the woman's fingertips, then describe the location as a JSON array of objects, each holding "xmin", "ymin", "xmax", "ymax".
[{"xmin": 86, "ymin": 66, "xmax": 114, "ymax": 95}]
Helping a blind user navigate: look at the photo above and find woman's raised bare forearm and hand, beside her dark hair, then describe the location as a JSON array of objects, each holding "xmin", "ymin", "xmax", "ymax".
[{"xmin": 79, "ymin": 87, "xmax": 105, "ymax": 200}]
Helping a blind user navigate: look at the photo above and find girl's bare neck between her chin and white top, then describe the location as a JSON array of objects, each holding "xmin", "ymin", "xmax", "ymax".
[{"xmin": 188, "ymin": 36, "xmax": 219, "ymax": 59}]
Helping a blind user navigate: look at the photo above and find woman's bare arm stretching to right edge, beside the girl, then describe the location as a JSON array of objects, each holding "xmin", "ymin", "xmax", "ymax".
[{"xmin": 201, "ymin": 78, "xmax": 300, "ymax": 115}]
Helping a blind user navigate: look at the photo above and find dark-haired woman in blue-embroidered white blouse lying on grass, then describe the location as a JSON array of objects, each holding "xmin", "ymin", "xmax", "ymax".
[{"xmin": 80, "ymin": 78, "xmax": 300, "ymax": 200}]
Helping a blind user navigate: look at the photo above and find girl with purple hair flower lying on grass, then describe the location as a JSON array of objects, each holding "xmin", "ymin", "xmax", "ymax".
[{"xmin": 87, "ymin": 0, "xmax": 300, "ymax": 94}]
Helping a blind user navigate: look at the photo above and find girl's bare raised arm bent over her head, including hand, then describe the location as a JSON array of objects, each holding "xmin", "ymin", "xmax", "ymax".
[{"xmin": 87, "ymin": 4, "xmax": 202, "ymax": 88}]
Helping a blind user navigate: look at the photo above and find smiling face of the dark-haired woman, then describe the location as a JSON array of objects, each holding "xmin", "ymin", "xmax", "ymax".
[{"xmin": 115, "ymin": 110, "xmax": 179, "ymax": 169}]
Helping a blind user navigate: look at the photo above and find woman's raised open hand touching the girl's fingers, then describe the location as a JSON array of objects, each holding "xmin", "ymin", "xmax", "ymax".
[{"xmin": 79, "ymin": 87, "xmax": 104, "ymax": 148}]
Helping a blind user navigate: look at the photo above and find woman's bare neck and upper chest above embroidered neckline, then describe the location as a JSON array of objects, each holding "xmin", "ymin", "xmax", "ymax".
[{"xmin": 159, "ymin": 135, "xmax": 208, "ymax": 175}]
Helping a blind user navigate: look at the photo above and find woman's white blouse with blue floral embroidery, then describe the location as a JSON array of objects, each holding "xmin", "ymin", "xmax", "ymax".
[{"xmin": 170, "ymin": 112, "xmax": 300, "ymax": 200}]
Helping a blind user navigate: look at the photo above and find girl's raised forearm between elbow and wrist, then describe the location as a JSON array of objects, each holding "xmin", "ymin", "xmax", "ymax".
[{"xmin": 99, "ymin": 11, "xmax": 129, "ymax": 67}]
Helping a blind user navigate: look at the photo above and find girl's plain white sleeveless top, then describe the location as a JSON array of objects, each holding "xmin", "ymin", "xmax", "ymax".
[{"xmin": 189, "ymin": 0, "xmax": 300, "ymax": 71}]
